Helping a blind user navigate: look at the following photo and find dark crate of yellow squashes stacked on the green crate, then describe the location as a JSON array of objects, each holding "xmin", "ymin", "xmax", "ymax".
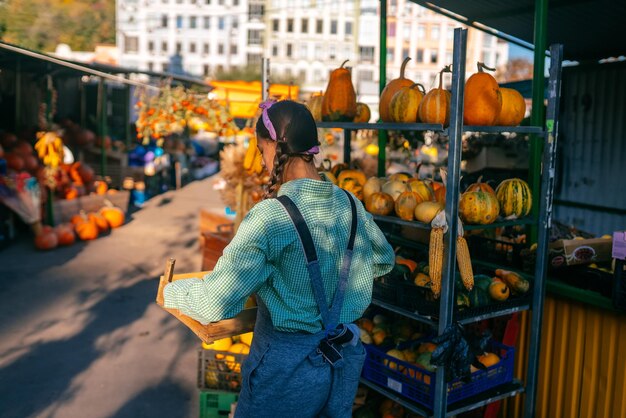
[{"xmin": 197, "ymin": 349, "xmax": 248, "ymax": 393}]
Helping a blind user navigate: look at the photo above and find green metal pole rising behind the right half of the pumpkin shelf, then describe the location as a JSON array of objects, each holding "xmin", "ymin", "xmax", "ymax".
[{"xmin": 528, "ymin": 0, "xmax": 548, "ymax": 242}]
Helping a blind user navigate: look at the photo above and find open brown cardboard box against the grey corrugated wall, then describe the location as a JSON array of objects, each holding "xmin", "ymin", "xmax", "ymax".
[{"xmin": 548, "ymin": 238, "xmax": 613, "ymax": 268}]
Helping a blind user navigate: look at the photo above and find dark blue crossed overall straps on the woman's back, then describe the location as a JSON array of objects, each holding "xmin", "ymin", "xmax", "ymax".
[{"xmin": 277, "ymin": 190, "xmax": 358, "ymax": 364}]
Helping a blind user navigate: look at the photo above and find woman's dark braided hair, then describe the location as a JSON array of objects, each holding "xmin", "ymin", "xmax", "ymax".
[{"xmin": 256, "ymin": 100, "xmax": 320, "ymax": 198}]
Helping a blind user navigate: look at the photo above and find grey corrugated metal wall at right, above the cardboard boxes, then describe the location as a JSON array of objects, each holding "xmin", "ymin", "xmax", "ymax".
[{"xmin": 554, "ymin": 62, "xmax": 626, "ymax": 235}]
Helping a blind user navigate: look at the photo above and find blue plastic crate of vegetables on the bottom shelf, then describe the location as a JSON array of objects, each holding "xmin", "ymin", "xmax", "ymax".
[{"xmin": 362, "ymin": 341, "xmax": 515, "ymax": 408}]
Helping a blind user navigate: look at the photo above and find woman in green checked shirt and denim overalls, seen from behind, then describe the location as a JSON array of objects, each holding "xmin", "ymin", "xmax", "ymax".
[{"xmin": 164, "ymin": 101, "xmax": 394, "ymax": 418}]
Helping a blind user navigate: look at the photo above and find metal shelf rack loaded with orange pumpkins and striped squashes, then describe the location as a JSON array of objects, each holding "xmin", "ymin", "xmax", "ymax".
[{"xmin": 313, "ymin": 29, "xmax": 562, "ymax": 417}]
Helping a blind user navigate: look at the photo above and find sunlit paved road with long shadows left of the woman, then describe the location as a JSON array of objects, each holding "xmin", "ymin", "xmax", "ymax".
[{"xmin": 0, "ymin": 179, "xmax": 227, "ymax": 418}]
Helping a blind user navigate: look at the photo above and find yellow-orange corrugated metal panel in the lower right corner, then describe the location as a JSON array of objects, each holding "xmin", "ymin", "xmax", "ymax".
[{"xmin": 500, "ymin": 297, "xmax": 626, "ymax": 418}]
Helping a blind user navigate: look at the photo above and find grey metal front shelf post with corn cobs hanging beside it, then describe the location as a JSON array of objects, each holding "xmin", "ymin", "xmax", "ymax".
[{"xmin": 433, "ymin": 28, "xmax": 467, "ymax": 418}]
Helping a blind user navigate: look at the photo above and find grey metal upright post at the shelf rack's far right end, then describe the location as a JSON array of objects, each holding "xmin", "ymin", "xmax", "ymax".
[{"xmin": 524, "ymin": 41, "xmax": 563, "ymax": 418}]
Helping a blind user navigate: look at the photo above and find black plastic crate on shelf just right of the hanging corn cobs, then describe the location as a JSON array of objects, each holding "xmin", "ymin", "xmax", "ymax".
[{"xmin": 467, "ymin": 235, "xmax": 528, "ymax": 269}]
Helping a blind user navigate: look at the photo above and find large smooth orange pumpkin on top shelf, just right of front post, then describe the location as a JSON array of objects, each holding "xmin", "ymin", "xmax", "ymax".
[{"xmin": 463, "ymin": 62, "xmax": 502, "ymax": 126}]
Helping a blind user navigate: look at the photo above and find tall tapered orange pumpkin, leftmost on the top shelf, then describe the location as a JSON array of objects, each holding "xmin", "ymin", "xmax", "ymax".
[{"xmin": 322, "ymin": 60, "xmax": 356, "ymax": 122}]
